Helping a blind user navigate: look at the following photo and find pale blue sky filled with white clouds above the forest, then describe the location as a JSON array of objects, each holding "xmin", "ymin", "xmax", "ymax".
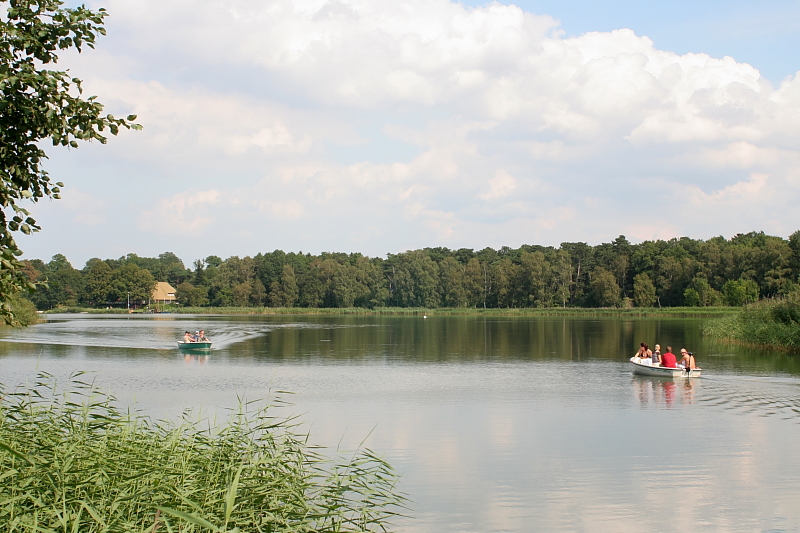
[{"xmin": 18, "ymin": 0, "xmax": 800, "ymax": 268}]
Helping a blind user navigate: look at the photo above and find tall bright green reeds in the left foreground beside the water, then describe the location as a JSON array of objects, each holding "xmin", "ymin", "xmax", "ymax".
[{"xmin": 0, "ymin": 375, "xmax": 405, "ymax": 533}]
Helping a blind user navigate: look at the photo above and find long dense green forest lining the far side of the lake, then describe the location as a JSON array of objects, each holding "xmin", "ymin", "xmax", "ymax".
[{"xmin": 25, "ymin": 231, "xmax": 800, "ymax": 310}]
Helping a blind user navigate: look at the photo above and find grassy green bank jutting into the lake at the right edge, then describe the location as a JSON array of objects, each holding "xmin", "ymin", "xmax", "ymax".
[{"xmin": 704, "ymin": 292, "xmax": 800, "ymax": 351}]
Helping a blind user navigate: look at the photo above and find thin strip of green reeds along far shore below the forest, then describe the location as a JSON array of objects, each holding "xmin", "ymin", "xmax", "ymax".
[{"xmin": 43, "ymin": 306, "xmax": 737, "ymax": 318}]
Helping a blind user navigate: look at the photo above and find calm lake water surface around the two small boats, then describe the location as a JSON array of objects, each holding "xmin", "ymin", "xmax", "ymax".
[{"xmin": 0, "ymin": 315, "xmax": 800, "ymax": 532}]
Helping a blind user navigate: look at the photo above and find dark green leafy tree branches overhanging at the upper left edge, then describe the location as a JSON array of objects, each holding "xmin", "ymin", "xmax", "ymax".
[{"xmin": 0, "ymin": 0, "xmax": 139, "ymax": 322}]
